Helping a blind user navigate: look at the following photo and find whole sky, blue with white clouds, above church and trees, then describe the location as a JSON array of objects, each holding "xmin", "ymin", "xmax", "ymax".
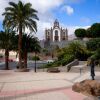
[{"xmin": 0, "ymin": 0, "xmax": 100, "ymax": 40}]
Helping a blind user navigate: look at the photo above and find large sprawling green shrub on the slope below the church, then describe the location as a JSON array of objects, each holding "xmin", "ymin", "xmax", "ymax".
[{"xmin": 44, "ymin": 41, "xmax": 93, "ymax": 68}]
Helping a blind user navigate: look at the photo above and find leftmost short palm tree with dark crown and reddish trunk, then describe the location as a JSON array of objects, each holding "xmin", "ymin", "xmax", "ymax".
[{"xmin": 0, "ymin": 29, "xmax": 15, "ymax": 70}]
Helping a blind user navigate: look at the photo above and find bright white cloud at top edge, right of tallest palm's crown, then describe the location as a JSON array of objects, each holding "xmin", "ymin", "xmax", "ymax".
[{"xmin": 22, "ymin": 0, "xmax": 64, "ymax": 13}]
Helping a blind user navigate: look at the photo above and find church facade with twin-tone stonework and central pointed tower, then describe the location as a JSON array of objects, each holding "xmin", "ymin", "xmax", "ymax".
[{"xmin": 45, "ymin": 19, "xmax": 68, "ymax": 42}]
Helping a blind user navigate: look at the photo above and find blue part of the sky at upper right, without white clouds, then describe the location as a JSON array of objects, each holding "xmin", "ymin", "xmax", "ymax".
[{"xmin": 53, "ymin": 0, "xmax": 100, "ymax": 26}]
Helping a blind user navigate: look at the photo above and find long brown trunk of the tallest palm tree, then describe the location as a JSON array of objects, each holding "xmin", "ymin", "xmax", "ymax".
[{"xmin": 18, "ymin": 24, "xmax": 22, "ymax": 69}]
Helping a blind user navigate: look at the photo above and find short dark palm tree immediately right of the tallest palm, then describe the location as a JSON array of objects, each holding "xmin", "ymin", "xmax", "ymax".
[{"xmin": 22, "ymin": 34, "xmax": 41, "ymax": 69}]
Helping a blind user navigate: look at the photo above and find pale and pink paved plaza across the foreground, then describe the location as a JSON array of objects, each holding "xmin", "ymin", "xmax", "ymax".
[{"xmin": 0, "ymin": 70, "xmax": 100, "ymax": 100}]
